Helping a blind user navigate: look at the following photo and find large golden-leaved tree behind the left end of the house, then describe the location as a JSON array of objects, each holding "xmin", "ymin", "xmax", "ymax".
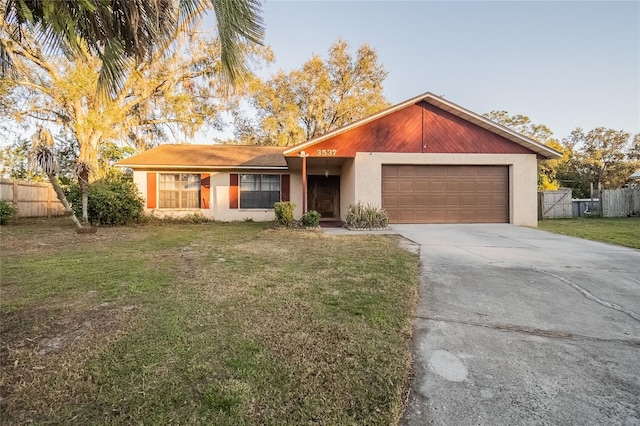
[{"xmin": 0, "ymin": 10, "xmax": 265, "ymax": 225}]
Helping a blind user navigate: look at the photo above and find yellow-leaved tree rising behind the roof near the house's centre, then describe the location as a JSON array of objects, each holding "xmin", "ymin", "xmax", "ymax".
[{"xmin": 235, "ymin": 40, "xmax": 389, "ymax": 146}]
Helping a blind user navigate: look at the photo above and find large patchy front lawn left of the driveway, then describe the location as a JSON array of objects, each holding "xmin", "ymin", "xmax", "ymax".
[{"xmin": 0, "ymin": 221, "xmax": 418, "ymax": 425}]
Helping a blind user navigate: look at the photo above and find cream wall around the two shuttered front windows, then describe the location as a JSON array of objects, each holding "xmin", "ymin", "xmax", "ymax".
[{"xmin": 133, "ymin": 170, "xmax": 302, "ymax": 222}]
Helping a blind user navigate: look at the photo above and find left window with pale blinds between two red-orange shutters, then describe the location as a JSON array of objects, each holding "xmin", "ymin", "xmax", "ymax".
[{"xmin": 159, "ymin": 173, "xmax": 200, "ymax": 209}]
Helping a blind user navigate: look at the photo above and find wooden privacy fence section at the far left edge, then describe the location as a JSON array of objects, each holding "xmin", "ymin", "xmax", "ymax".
[{"xmin": 0, "ymin": 179, "xmax": 64, "ymax": 217}]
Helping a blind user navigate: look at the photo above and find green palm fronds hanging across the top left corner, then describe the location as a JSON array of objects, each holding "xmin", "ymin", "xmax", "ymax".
[{"xmin": 0, "ymin": 0, "xmax": 264, "ymax": 95}]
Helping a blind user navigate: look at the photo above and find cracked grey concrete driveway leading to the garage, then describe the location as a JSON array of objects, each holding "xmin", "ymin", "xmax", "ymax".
[{"xmin": 392, "ymin": 224, "xmax": 640, "ymax": 425}]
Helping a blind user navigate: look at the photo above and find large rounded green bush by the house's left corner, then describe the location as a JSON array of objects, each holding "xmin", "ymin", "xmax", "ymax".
[{"xmin": 66, "ymin": 180, "xmax": 144, "ymax": 226}]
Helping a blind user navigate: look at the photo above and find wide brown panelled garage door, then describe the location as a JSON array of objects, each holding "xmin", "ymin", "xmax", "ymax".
[{"xmin": 382, "ymin": 165, "xmax": 509, "ymax": 223}]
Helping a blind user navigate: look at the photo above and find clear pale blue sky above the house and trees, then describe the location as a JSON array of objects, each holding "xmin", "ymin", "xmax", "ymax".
[{"xmin": 259, "ymin": 1, "xmax": 640, "ymax": 139}]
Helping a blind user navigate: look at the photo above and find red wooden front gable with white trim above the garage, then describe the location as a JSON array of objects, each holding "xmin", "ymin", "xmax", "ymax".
[{"xmin": 284, "ymin": 93, "xmax": 561, "ymax": 158}]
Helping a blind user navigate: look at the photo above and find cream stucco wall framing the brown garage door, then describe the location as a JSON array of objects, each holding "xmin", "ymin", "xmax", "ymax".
[{"xmin": 350, "ymin": 152, "xmax": 538, "ymax": 227}]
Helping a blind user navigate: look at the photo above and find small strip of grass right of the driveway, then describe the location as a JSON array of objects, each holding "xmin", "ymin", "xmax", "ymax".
[{"xmin": 538, "ymin": 217, "xmax": 640, "ymax": 249}]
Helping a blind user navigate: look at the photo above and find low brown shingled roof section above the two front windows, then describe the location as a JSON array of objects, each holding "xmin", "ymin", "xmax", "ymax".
[{"xmin": 117, "ymin": 144, "xmax": 287, "ymax": 169}]
